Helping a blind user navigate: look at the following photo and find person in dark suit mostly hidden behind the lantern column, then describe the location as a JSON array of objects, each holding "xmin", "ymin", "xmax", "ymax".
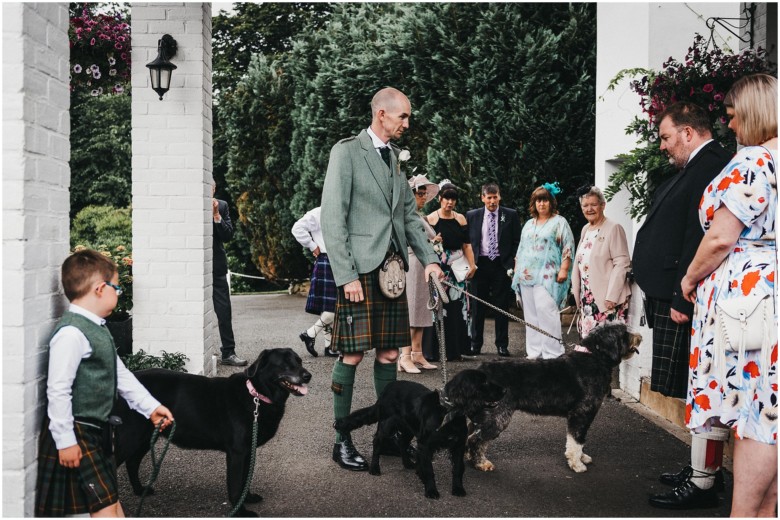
[{"xmin": 211, "ymin": 184, "xmax": 247, "ymax": 367}]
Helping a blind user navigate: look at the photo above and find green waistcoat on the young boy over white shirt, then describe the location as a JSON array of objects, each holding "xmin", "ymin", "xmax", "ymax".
[{"xmin": 52, "ymin": 311, "xmax": 117, "ymax": 421}]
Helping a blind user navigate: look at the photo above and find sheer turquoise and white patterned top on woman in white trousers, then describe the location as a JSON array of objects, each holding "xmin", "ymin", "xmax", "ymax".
[{"xmin": 512, "ymin": 215, "xmax": 574, "ymax": 309}]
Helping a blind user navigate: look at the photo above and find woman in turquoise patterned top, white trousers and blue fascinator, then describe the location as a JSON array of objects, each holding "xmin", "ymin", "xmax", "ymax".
[{"xmin": 512, "ymin": 182, "xmax": 574, "ymax": 359}]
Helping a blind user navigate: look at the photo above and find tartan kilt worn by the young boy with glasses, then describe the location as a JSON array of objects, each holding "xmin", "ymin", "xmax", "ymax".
[{"xmin": 35, "ymin": 417, "xmax": 119, "ymax": 517}]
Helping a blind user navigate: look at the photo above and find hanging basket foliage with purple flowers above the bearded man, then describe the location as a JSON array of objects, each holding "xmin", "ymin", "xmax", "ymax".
[{"xmin": 605, "ymin": 34, "xmax": 768, "ymax": 219}]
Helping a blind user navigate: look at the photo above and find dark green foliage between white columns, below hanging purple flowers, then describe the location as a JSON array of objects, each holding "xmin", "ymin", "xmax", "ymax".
[{"xmin": 70, "ymin": 92, "xmax": 132, "ymax": 218}]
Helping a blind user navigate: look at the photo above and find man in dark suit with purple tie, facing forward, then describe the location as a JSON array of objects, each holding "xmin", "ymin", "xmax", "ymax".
[{"xmin": 466, "ymin": 182, "xmax": 521, "ymax": 356}]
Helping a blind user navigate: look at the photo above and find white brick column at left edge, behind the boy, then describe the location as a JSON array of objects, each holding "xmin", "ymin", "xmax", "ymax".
[{"xmin": 3, "ymin": 3, "xmax": 70, "ymax": 517}]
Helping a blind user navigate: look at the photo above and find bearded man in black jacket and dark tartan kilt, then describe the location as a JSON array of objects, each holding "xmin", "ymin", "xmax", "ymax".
[{"xmin": 633, "ymin": 102, "xmax": 731, "ymax": 509}]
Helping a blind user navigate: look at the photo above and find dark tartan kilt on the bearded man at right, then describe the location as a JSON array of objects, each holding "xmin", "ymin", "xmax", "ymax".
[{"xmin": 645, "ymin": 298, "xmax": 691, "ymax": 399}]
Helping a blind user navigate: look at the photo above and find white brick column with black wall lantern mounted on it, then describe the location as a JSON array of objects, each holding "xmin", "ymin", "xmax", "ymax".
[{"xmin": 131, "ymin": 3, "xmax": 219, "ymax": 374}]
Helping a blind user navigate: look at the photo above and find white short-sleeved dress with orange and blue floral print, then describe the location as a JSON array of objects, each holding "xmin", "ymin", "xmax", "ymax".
[{"xmin": 685, "ymin": 146, "xmax": 777, "ymax": 444}]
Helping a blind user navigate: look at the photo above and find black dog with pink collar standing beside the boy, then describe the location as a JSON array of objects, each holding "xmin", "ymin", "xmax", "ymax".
[{"xmin": 114, "ymin": 348, "xmax": 311, "ymax": 516}]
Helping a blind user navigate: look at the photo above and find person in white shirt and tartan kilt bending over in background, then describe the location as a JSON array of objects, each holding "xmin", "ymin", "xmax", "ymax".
[{"xmin": 292, "ymin": 206, "xmax": 338, "ymax": 357}]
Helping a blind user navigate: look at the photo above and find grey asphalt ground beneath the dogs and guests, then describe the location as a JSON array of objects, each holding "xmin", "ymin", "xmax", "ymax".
[{"xmin": 114, "ymin": 294, "xmax": 732, "ymax": 518}]
